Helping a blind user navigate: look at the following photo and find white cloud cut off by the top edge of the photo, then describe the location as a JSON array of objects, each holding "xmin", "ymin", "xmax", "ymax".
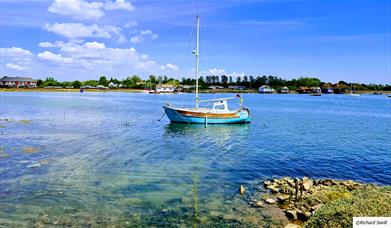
[{"xmin": 48, "ymin": 0, "xmax": 134, "ymax": 20}]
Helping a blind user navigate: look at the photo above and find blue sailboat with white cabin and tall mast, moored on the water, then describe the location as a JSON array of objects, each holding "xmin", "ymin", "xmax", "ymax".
[{"xmin": 163, "ymin": 15, "xmax": 250, "ymax": 124}]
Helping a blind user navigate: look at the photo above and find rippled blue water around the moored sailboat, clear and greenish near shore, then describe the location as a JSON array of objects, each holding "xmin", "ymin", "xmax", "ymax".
[{"xmin": 0, "ymin": 92, "xmax": 391, "ymax": 226}]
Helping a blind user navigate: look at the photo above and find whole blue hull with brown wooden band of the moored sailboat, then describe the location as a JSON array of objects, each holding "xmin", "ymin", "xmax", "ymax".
[{"xmin": 163, "ymin": 105, "xmax": 250, "ymax": 124}]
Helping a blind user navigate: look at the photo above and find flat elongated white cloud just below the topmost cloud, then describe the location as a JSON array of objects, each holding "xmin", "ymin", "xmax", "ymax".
[{"xmin": 44, "ymin": 23, "xmax": 126, "ymax": 39}]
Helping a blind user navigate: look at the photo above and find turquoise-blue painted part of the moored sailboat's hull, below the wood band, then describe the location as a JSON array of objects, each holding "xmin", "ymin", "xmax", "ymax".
[{"xmin": 163, "ymin": 106, "xmax": 250, "ymax": 124}]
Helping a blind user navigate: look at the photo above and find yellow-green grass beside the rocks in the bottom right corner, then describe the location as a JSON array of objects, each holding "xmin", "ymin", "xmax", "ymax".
[{"xmin": 305, "ymin": 186, "xmax": 391, "ymax": 227}]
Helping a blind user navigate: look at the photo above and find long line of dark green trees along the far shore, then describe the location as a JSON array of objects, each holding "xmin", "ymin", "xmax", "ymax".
[{"xmin": 37, "ymin": 75, "xmax": 391, "ymax": 91}]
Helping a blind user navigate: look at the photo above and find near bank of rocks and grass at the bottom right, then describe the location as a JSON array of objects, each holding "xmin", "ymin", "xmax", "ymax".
[{"xmin": 241, "ymin": 177, "xmax": 391, "ymax": 227}]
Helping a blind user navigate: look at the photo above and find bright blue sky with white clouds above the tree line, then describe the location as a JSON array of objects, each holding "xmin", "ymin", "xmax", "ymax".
[{"xmin": 0, "ymin": 0, "xmax": 391, "ymax": 84}]
